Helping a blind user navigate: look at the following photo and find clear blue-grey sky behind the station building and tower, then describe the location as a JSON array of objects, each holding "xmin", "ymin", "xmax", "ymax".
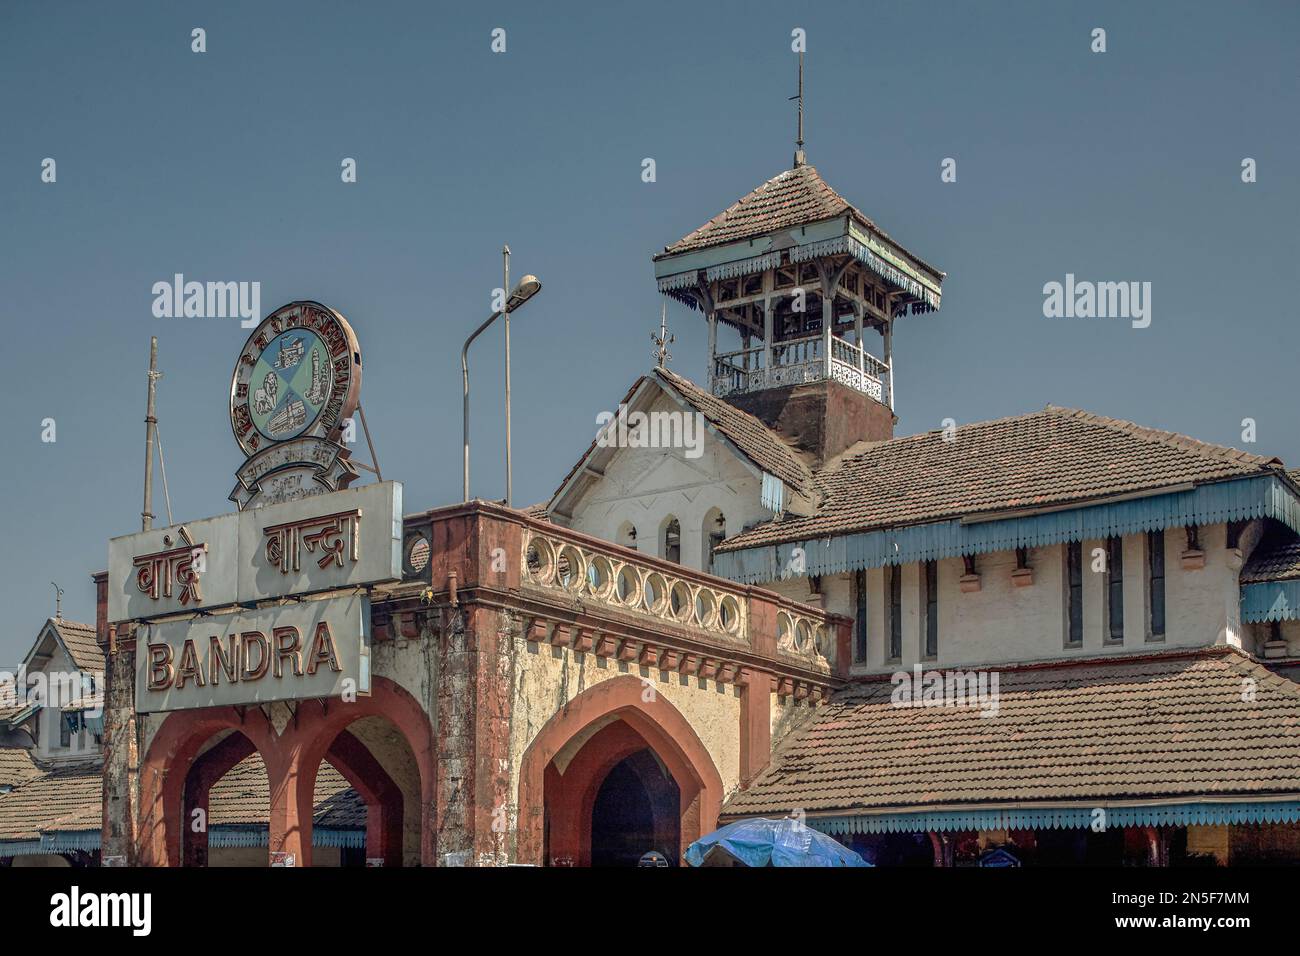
[{"xmin": 0, "ymin": 0, "xmax": 1300, "ymax": 663}]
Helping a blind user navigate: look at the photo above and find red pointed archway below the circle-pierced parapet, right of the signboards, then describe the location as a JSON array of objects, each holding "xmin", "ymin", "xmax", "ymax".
[{"xmin": 517, "ymin": 676, "xmax": 723, "ymax": 865}]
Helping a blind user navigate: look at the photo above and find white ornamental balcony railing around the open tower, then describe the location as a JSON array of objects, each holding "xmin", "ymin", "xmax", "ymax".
[{"xmin": 712, "ymin": 334, "xmax": 891, "ymax": 405}]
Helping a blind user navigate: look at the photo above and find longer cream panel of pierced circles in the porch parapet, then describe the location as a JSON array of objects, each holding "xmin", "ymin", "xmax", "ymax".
[{"xmin": 523, "ymin": 528, "xmax": 749, "ymax": 643}]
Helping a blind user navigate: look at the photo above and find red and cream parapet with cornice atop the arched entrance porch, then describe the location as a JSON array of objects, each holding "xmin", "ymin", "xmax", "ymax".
[{"xmin": 395, "ymin": 501, "xmax": 853, "ymax": 686}]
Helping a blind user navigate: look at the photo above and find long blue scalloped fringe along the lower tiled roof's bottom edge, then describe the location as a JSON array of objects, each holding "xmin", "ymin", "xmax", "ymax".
[{"xmin": 807, "ymin": 800, "xmax": 1300, "ymax": 835}]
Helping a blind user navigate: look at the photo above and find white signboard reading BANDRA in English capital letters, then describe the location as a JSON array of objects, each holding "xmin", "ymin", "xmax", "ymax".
[{"xmin": 135, "ymin": 593, "xmax": 371, "ymax": 713}]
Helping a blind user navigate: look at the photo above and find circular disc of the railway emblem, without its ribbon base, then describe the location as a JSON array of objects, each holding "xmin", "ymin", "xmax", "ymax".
[{"xmin": 230, "ymin": 302, "xmax": 361, "ymax": 457}]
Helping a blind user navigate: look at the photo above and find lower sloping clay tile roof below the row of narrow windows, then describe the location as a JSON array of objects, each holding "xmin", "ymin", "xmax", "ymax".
[{"xmin": 723, "ymin": 648, "xmax": 1300, "ymax": 816}]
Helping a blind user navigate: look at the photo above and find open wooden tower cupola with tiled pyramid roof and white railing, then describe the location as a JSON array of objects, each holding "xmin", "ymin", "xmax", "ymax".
[{"xmin": 654, "ymin": 153, "xmax": 944, "ymax": 459}]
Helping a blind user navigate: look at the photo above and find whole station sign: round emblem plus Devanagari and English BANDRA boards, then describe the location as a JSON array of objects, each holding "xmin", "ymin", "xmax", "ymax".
[{"xmin": 107, "ymin": 302, "xmax": 387, "ymax": 713}]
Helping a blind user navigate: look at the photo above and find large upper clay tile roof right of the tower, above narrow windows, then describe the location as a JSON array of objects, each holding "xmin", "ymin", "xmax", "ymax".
[{"xmin": 719, "ymin": 406, "xmax": 1281, "ymax": 551}]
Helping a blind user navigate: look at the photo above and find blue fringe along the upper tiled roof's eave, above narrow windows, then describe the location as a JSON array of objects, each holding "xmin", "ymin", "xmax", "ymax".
[{"xmin": 712, "ymin": 475, "xmax": 1300, "ymax": 584}]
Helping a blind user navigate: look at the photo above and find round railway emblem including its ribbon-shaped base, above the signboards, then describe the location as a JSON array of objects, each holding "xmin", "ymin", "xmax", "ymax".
[{"xmin": 230, "ymin": 302, "xmax": 361, "ymax": 510}]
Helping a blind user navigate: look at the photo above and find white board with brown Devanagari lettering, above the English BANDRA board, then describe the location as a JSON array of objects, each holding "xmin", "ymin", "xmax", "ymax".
[{"xmin": 108, "ymin": 481, "xmax": 402, "ymax": 623}]
